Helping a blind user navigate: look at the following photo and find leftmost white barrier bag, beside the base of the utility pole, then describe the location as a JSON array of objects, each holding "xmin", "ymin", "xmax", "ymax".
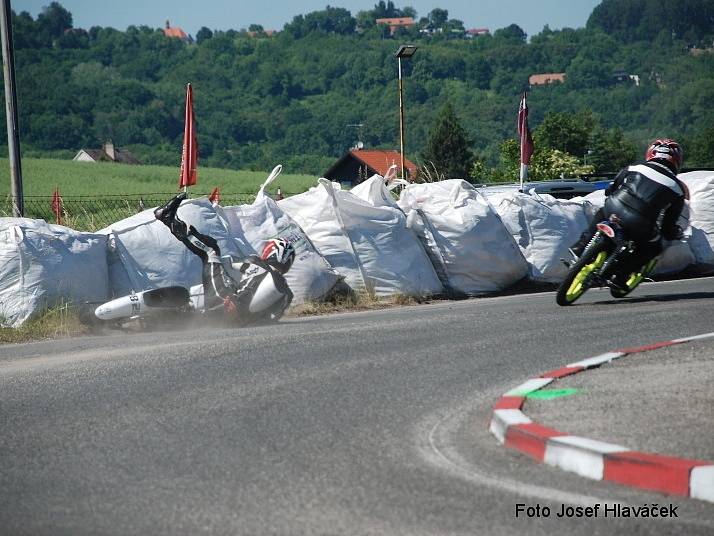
[{"xmin": 0, "ymin": 218, "xmax": 109, "ymax": 327}]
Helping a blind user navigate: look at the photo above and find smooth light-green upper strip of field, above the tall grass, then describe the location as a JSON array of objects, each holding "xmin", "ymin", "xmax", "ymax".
[{"xmin": 0, "ymin": 158, "xmax": 317, "ymax": 198}]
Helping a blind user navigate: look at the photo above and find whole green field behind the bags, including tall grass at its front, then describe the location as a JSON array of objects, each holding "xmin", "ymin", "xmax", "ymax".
[{"xmin": 0, "ymin": 158, "xmax": 317, "ymax": 231}]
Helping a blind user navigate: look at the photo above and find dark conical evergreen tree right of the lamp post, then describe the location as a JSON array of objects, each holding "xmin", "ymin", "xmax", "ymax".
[{"xmin": 422, "ymin": 102, "xmax": 474, "ymax": 179}]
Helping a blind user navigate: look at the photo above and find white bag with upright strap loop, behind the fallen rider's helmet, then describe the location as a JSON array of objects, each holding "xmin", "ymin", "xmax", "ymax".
[{"xmin": 224, "ymin": 166, "xmax": 341, "ymax": 304}]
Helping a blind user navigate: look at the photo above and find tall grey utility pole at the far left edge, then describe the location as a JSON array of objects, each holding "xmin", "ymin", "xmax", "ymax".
[{"xmin": 0, "ymin": 0, "xmax": 25, "ymax": 218}]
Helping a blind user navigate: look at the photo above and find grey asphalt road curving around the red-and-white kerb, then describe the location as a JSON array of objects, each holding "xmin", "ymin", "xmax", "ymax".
[{"xmin": 0, "ymin": 278, "xmax": 714, "ymax": 535}]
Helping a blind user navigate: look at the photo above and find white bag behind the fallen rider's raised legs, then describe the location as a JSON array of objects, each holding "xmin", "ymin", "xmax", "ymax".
[{"xmin": 98, "ymin": 197, "xmax": 245, "ymax": 296}]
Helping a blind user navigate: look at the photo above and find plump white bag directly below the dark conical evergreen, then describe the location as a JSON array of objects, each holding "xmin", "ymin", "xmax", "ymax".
[{"xmin": 399, "ymin": 179, "xmax": 528, "ymax": 295}]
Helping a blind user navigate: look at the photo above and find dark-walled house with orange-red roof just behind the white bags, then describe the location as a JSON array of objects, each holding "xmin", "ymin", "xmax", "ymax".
[{"xmin": 323, "ymin": 149, "xmax": 418, "ymax": 186}]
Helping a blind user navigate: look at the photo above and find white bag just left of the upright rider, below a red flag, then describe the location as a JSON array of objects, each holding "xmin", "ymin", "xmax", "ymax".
[{"xmin": 495, "ymin": 192, "xmax": 592, "ymax": 283}]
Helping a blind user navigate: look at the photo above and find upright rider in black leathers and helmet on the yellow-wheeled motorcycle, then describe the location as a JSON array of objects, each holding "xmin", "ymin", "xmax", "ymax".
[{"xmin": 571, "ymin": 139, "xmax": 688, "ymax": 288}]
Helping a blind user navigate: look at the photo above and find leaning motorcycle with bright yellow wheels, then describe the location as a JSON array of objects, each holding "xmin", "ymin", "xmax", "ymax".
[{"xmin": 555, "ymin": 214, "xmax": 657, "ymax": 305}]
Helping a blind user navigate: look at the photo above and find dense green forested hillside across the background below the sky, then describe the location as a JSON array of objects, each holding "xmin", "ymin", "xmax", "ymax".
[{"xmin": 5, "ymin": 0, "xmax": 714, "ymax": 182}]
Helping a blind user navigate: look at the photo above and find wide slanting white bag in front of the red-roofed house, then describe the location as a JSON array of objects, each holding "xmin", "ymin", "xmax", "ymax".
[{"xmin": 278, "ymin": 179, "xmax": 442, "ymax": 296}]
